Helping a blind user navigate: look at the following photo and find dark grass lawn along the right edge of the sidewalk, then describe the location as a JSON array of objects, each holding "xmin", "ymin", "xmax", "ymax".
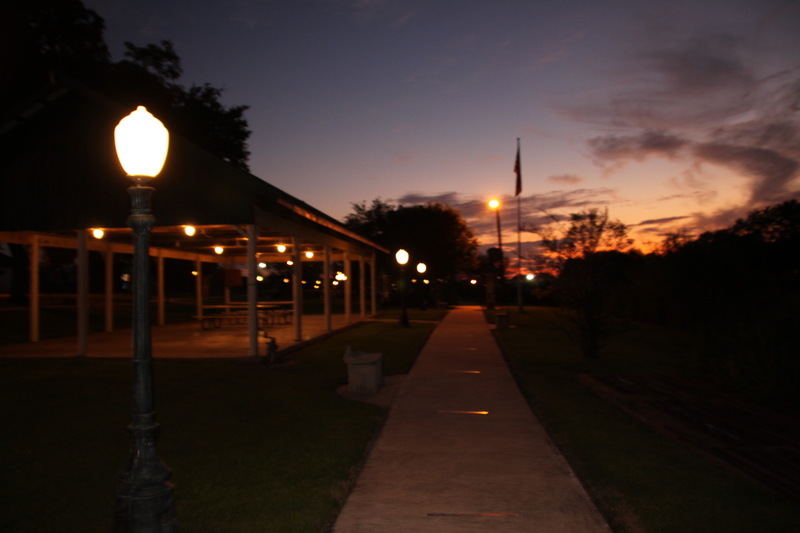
[{"xmin": 489, "ymin": 308, "xmax": 800, "ymax": 533}]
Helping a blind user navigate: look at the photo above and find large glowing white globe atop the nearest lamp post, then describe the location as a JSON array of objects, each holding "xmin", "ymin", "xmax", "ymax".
[{"xmin": 114, "ymin": 106, "xmax": 169, "ymax": 181}]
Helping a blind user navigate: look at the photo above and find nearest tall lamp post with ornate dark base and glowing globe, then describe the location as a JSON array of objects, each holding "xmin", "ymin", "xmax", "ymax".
[{"xmin": 114, "ymin": 106, "xmax": 178, "ymax": 533}]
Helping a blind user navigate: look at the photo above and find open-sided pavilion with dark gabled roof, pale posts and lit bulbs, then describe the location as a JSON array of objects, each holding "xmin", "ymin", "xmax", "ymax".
[{"xmin": 0, "ymin": 81, "xmax": 388, "ymax": 356}]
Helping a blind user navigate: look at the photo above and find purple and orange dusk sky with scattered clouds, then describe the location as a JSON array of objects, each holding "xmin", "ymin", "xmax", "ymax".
[{"xmin": 84, "ymin": 0, "xmax": 800, "ymax": 253}]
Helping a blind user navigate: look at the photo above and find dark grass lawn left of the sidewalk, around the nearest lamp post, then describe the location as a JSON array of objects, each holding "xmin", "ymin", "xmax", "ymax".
[{"xmin": 0, "ymin": 322, "xmax": 434, "ymax": 533}]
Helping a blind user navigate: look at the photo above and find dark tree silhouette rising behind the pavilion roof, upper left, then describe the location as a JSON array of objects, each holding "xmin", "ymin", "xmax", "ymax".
[{"xmin": 0, "ymin": 0, "xmax": 251, "ymax": 170}]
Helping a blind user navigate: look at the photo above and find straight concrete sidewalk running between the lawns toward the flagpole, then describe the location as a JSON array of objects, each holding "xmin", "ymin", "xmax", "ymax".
[{"xmin": 334, "ymin": 307, "xmax": 610, "ymax": 533}]
